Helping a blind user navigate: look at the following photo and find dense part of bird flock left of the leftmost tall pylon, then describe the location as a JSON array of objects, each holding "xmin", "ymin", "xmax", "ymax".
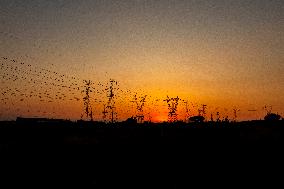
[{"xmin": 0, "ymin": 57, "xmax": 82, "ymax": 118}]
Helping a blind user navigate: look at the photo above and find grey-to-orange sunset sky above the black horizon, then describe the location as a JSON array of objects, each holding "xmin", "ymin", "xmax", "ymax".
[{"xmin": 0, "ymin": 0, "xmax": 284, "ymax": 121}]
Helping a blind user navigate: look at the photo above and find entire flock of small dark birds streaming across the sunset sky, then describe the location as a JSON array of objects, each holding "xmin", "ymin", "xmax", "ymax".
[{"xmin": 0, "ymin": 56, "xmax": 266, "ymax": 120}]
